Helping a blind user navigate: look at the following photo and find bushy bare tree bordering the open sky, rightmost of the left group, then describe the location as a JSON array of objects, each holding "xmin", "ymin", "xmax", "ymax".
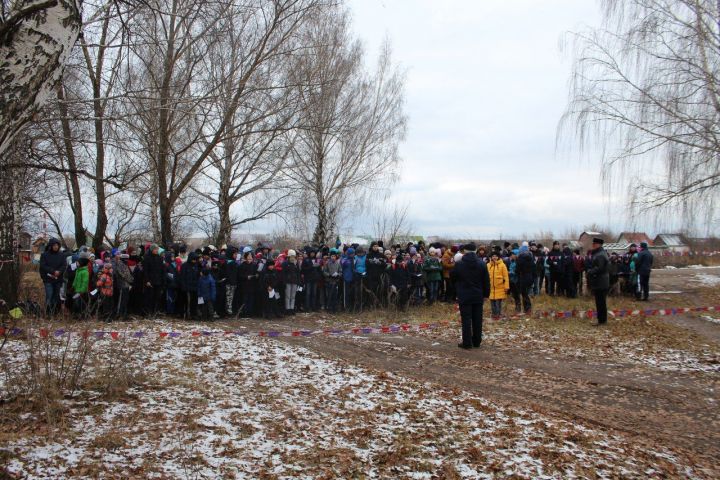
[{"xmin": 293, "ymin": 9, "xmax": 406, "ymax": 243}]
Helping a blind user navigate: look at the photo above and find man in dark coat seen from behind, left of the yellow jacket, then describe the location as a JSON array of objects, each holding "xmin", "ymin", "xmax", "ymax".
[{"xmin": 451, "ymin": 243, "xmax": 490, "ymax": 349}]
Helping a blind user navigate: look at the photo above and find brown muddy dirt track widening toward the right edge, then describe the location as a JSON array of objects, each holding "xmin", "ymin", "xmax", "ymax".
[{"xmin": 7, "ymin": 268, "xmax": 720, "ymax": 478}]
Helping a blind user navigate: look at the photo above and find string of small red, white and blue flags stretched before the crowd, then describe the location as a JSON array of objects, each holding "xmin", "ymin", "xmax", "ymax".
[{"xmin": 0, "ymin": 305, "xmax": 720, "ymax": 340}]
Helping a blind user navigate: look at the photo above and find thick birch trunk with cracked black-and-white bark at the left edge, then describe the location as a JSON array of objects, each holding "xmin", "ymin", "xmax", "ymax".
[{"xmin": 0, "ymin": 0, "xmax": 80, "ymax": 304}]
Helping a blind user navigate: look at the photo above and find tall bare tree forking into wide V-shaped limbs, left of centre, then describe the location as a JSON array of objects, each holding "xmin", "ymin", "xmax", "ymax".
[{"xmin": 126, "ymin": 0, "xmax": 321, "ymax": 243}]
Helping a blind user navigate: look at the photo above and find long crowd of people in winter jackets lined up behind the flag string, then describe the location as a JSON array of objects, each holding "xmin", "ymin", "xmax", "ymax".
[{"xmin": 40, "ymin": 239, "xmax": 652, "ymax": 320}]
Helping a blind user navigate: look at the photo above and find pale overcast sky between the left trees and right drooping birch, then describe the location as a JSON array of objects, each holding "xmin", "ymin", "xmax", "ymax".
[{"xmin": 334, "ymin": 0, "xmax": 626, "ymax": 237}]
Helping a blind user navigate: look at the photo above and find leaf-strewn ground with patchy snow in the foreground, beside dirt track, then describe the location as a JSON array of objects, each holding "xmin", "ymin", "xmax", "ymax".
[{"xmin": 0, "ymin": 325, "xmax": 703, "ymax": 479}]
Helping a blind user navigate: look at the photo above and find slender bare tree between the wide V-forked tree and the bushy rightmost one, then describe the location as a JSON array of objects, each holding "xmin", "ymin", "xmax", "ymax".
[{"xmin": 193, "ymin": 5, "xmax": 299, "ymax": 245}]
